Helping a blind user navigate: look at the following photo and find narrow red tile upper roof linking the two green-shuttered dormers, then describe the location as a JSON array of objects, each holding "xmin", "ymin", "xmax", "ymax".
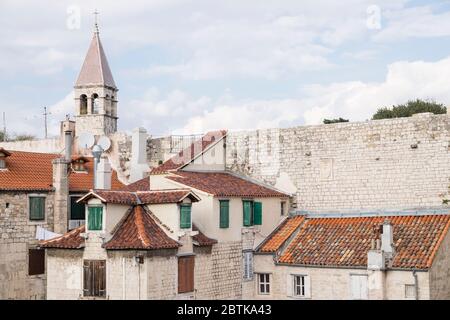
[{"xmin": 79, "ymin": 189, "xmax": 200, "ymax": 205}]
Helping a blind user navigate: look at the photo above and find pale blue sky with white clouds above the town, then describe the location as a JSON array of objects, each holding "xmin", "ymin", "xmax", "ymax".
[{"xmin": 0, "ymin": 0, "xmax": 450, "ymax": 138}]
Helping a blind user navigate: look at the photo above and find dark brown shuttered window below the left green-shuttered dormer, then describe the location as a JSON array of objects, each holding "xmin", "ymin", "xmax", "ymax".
[{"xmin": 83, "ymin": 260, "xmax": 106, "ymax": 297}]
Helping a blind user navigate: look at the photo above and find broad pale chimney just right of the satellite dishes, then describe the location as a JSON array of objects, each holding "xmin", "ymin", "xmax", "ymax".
[{"xmin": 129, "ymin": 128, "xmax": 149, "ymax": 182}]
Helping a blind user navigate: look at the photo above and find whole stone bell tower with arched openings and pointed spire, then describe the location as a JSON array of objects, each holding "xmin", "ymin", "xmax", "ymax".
[{"xmin": 74, "ymin": 12, "xmax": 119, "ymax": 135}]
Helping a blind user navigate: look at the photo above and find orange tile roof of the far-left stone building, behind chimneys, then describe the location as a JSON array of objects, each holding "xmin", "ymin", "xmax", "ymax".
[{"xmin": 0, "ymin": 151, "xmax": 124, "ymax": 192}]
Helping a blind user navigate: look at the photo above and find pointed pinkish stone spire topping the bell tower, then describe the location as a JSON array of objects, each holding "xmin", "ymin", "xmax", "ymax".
[{"xmin": 75, "ymin": 27, "xmax": 116, "ymax": 88}]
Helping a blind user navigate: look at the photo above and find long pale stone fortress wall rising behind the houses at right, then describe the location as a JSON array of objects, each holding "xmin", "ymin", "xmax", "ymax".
[{"xmin": 227, "ymin": 113, "xmax": 450, "ymax": 211}]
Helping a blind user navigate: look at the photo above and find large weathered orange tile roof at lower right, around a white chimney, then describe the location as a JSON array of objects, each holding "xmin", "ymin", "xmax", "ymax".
[{"xmin": 279, "ymin": 215, "xmax": 450, "ymax": 269}]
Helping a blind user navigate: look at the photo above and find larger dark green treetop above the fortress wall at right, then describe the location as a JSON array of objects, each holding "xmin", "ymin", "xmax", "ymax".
[{"xmin": 372, "ymin": 99, "xmax": 447, "ymax": 120}]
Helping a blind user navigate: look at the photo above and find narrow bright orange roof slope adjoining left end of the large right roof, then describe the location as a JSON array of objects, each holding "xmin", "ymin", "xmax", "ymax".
[{"xmin": 257, "ymin": 216, "xmax": 305, "ymax": 252}]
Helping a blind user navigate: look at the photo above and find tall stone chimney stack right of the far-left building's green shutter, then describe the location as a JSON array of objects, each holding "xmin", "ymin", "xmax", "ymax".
[{"xmin": 52, "ymin": 158, "xmax": 70, "ymax": 234}]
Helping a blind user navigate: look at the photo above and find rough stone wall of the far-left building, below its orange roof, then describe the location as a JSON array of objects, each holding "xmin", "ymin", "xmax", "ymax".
[{"xmin": 0, "ymin": 192, "xmax": 54, "ymax": 299}]
